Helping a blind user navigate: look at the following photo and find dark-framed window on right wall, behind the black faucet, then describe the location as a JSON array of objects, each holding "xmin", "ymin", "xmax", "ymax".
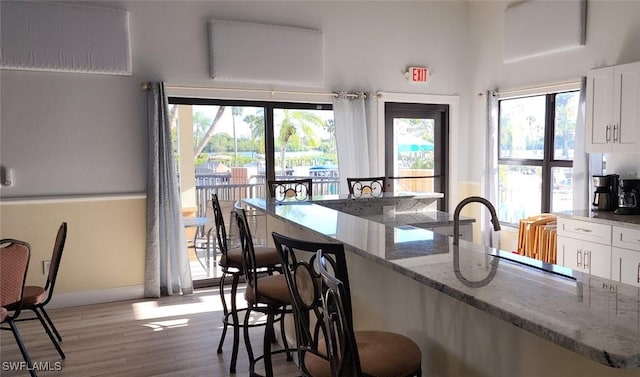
[{"xmin": 497, "ymin": 91, "xmax": 580, "ymax": 225}]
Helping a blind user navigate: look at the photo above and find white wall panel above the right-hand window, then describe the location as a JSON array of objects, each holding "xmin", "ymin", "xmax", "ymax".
[{"xmin": 504, "ymin": 0, "xmax": 587, "ymax": 63}]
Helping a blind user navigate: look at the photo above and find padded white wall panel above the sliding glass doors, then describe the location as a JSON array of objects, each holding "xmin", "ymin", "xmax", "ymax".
[{"xmin": 209, "ymin": 20, "xmax": 324, "ymax": 86}]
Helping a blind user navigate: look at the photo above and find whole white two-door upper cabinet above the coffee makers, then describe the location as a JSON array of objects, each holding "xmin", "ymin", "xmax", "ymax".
[{"xmin": 585, "ymin": 62, "xmax": 640, "ymax": 153}]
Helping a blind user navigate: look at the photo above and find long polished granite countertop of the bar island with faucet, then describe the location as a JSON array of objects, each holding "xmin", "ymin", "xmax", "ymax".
[{"xmin": 245, "ymin": 199, "xmax": 640, "ymax": 368}]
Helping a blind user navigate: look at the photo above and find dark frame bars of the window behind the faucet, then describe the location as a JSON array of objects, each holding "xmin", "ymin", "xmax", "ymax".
[{"xmin": 495, "ymin": 88, "xmax": 580, "ymax": 223}]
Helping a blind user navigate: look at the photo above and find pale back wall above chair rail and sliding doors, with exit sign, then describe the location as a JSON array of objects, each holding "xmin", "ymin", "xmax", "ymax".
[{"xmin": 0, "ymin": 1, "xmax": 467, "ymax": 197}]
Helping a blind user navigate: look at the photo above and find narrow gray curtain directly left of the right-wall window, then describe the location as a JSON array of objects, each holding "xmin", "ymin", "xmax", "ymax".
[{"xmin": 480, "ymin": 90, "xmax": 500, "ymax": 248}]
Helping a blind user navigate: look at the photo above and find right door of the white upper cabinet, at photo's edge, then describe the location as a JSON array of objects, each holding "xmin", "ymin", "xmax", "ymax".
[{"xmin": 612, "ymin": 62, "xmax": 640, "ymax": 152}]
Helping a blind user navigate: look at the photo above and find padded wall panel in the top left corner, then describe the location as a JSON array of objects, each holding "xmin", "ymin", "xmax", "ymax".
[{"xmin": 0, "ymin": 1, "xmax": 131, "ymax": 75}]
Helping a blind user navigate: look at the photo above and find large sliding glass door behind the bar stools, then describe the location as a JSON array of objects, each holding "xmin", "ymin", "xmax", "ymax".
[{"xmin": 169, "ymin": 97, "xmax": 339, "ymax": 286}]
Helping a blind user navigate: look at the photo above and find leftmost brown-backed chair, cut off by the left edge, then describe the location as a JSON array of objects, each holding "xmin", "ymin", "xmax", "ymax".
[{"xmin": 0, "ymin": 239, "xmax": 37, "ymax": 377}]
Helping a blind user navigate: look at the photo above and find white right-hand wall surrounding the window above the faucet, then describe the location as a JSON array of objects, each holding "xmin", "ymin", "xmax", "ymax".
[{"xmin": 460, "ymin": 0, "xmax": 640, "ymax": 181}]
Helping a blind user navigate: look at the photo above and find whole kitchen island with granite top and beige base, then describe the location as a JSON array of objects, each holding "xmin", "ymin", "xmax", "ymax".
[{"xmin": 245, "ymin": 195, "xmax": 640, "ymax": 377}]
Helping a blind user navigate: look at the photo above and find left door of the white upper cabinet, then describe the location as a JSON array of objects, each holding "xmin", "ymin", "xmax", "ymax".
[{"xmin": 585, "ymin": 67, "xmax": 613, "ymax": 152}]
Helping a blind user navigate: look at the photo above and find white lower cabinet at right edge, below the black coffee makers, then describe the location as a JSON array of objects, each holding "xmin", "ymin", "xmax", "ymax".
[{"xmin": 611, "ymin": 226, "xmax": 640, "ymax": 287}]
